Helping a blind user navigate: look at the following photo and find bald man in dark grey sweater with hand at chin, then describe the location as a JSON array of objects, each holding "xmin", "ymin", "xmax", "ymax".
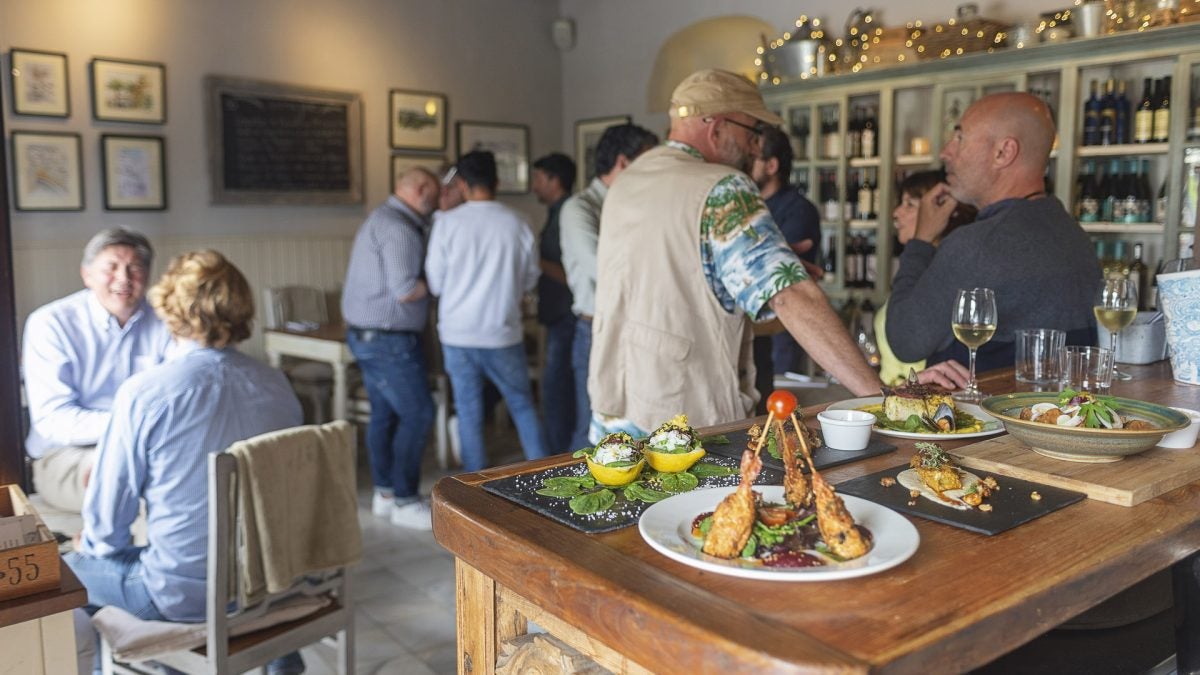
[{"xmin": 887, "ymin": 92, "xmax": 1100, "ymax": 370}]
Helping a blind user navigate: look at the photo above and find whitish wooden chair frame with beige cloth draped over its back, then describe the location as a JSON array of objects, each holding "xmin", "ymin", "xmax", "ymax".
[{"xmin": 92, "ymin": 420, "xmax": 359, "ymax": 675}]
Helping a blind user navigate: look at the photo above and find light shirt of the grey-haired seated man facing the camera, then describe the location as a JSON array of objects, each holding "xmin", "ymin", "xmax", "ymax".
[{"xmin": 22, "ymin": 289, "xmax": 172, "ymax": 459}]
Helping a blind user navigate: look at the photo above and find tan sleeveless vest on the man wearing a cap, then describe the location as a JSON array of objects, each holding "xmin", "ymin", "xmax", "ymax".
[{"xmin": 588, "ymin": 145, "xmax": 757, "ymax": 431}]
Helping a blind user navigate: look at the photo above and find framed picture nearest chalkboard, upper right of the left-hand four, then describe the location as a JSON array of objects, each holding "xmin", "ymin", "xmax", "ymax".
[{"xmin": 91, "ymin": 59, "xmax": 167, "ymax": 124}]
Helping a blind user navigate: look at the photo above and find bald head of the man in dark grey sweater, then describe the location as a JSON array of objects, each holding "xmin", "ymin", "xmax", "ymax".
[{"xmin": 941, "ymin": 91, "xmax": 1055, "ymax": 208}]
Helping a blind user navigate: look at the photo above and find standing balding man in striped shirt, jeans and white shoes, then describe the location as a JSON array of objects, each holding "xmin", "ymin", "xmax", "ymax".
[{"xmin": 342, "ymin": 168, "xmax": 440, "ymax": 530}]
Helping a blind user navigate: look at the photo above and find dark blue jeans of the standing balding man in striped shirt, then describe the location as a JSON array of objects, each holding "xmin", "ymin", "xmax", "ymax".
[{"xmin": 346, "ymin": 329, "xmax": 433, "ymax": 500}]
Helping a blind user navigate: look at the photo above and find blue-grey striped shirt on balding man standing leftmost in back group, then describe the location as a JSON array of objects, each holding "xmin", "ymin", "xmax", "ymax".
[{"xmin": 342, "ymin": 195, "xmax": 430, "ymax": 331}]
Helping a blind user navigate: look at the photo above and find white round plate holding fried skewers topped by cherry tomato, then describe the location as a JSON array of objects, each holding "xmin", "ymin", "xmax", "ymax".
[{"xmin": 637, "ymin": 485, "xmax": 920, "ymax": 581}]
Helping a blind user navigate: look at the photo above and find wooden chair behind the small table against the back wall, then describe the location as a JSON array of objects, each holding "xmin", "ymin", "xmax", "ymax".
[{"xmin": 263, "ymin": 286, "xmax": 334, "ymax": 424}]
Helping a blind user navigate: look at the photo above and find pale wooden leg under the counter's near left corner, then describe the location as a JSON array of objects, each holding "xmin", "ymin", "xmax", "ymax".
[{"xmin": 455, "ymin": 558, "xmax": 496, "ymax": 675}]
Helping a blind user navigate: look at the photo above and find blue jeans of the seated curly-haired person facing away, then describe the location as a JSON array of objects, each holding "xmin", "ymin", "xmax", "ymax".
[{"xmin": 62, "ymin": 548, "xmax": 304, "ymax": 674}]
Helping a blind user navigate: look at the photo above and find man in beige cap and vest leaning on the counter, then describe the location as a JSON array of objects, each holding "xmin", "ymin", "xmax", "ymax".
[{"xmin": 588, "ymin": 70, "xmax": 966, "ymax": 442}]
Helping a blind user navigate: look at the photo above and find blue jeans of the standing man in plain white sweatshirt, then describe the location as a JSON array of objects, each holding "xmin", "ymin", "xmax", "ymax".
[{"xmin": 442, "ymin": 344, "xmax": 546, "ymax": 471}]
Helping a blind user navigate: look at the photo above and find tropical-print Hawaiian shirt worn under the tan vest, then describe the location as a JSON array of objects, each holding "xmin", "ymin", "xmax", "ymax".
[{"xmin": 588, "ymin": 141, "xmax": 809, "ymax": 443}]
